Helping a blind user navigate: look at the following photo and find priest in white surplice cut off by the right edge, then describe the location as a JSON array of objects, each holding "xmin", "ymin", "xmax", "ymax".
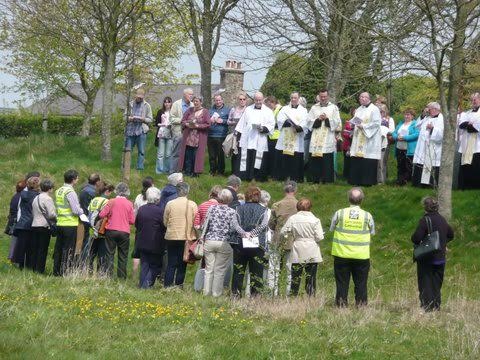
[{"xmin": 458, "ymin": 93, "xmax": 480, "ymax": 189}]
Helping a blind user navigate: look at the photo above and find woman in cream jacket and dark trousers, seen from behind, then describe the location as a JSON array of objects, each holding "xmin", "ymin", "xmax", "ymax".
[{"xmin": 280, "ymin": 198, "xmax": 323, "ymax": 296}]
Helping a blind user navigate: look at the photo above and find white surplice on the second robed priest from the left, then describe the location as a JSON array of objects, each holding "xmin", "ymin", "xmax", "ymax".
[{"xmin": 275, "ymin": 104, "xmax": 308, "ymax": 153}]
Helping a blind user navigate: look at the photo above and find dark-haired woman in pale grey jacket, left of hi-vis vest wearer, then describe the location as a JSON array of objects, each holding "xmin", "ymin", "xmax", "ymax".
[{"xmin": 32, "ymin": 179, "xmax": 57, "ymax": 274}]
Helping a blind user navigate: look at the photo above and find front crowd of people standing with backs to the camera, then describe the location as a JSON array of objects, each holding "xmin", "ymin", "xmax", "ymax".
[{"xmin": 6, "ymin": 170, "xmax": 453, "ymax": 310}]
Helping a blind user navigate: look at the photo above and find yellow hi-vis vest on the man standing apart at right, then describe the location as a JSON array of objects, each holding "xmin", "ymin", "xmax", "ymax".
[{"xmin": 332, "ymin": 207, "xmax": 371, "ymax": 260}]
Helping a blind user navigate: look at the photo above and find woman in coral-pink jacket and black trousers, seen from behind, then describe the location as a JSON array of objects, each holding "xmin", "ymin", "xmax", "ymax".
[{"xmin": 99, "ymin": 182, "xmax": 135, "ymax": 279}]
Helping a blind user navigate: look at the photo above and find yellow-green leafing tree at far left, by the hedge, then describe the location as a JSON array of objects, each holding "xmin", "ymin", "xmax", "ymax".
[{"xmin": 0, "ymin": 0, "xmax": 104, "ymax": 136}]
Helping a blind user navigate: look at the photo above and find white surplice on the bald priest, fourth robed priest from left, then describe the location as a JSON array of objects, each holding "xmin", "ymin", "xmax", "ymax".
[{"xmin": 350, "ymin": 103, "xmax": 382, "ymax": 160}]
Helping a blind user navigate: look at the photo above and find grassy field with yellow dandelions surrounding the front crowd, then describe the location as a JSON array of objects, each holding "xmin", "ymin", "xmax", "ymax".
[{"xmin": 0, "ymin": 135, "xmax": 480, "ymax": 359}]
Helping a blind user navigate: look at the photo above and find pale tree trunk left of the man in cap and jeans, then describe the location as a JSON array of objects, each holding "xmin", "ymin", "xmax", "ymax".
[{"xmin": 102, "ymin": 52, "xmax": 116, "ymax": 161}]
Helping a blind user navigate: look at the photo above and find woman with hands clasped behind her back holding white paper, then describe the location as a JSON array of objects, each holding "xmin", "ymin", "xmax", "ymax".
[{"xmin": 231, "ymin": 186, "xmax": 268, "ymax": 297}]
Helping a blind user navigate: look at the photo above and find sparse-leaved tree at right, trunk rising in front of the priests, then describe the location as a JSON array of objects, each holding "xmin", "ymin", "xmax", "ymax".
[{"xmin": 374, "ymin": 0, "xmax": 480, "ymax": 219}]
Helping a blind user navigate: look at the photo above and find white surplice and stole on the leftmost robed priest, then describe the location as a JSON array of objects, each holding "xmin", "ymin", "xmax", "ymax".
[{"xmin": 235, "ymin": 104, "xmax": 275, "ymax": 171}]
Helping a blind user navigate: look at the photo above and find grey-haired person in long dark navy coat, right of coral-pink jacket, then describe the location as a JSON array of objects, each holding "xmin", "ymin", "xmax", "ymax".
[{"xmin": 135, "ymin": 187, "xmax": 165, "ymax": 289}]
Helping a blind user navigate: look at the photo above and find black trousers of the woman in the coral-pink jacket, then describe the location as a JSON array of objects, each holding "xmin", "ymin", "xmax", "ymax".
[{"xmin": 102, "ymin": 230, "xmax": 130, "ymax": 279}]
